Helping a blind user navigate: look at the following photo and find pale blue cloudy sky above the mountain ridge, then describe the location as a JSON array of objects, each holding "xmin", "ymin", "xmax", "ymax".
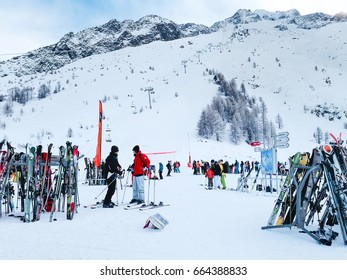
[{"xmin": 0, "ymin": 0, "xmax": 347, "ymax": 60}]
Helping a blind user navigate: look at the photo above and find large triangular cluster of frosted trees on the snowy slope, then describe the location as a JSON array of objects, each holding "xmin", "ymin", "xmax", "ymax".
[{"xmin": 197, "ymin": 70, "xmax": 283, "ymax": 146}]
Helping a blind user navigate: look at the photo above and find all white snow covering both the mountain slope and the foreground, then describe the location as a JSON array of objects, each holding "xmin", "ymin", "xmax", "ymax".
[{"xmin": 0, "ymin": 12, "xmax": 347, "ymax": 266}]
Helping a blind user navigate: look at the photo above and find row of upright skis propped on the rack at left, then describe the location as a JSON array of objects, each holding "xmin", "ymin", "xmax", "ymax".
[{"xmin": 0, "ymin": 140, "xmax": 79, "ymax": 222}]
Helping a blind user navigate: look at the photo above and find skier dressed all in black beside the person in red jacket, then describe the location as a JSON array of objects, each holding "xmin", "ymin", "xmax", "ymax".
[{"xmin": 102, "ymin": 146, "xmax": 122, "ymax": 208}]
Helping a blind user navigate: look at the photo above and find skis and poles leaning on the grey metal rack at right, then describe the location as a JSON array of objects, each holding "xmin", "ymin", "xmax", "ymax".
[{"xmin": 262, "ymin": 134, "xmax": 347, "ymax": 246}]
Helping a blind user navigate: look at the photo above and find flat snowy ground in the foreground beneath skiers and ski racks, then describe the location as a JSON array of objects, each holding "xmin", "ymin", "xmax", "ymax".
[{"xmin": 0, "ymin": 168, "xmax": 346, "ymax": 260}]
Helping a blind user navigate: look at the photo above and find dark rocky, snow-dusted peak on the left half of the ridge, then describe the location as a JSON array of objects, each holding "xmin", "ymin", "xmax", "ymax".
[{"xmin": 0, "ymin": 15, "xmax": 210, "ymax": 76}]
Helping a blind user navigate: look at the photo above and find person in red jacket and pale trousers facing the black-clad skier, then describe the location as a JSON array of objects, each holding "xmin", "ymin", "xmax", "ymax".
[{"xmin": 130, "ymin": 145, "xmax": 151, "ymax": 204}]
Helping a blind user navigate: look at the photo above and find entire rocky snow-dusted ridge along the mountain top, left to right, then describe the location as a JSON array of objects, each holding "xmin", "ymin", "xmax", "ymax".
[{"xmin": 0, "ymin": 9, "xmax": 347, "ymax": 76}]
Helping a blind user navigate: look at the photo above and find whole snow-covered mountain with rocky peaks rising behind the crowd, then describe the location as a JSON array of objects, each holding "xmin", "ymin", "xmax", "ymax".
[{"xmin": 0, "ymin": 10, "xmax": 347, "ymax": 164}]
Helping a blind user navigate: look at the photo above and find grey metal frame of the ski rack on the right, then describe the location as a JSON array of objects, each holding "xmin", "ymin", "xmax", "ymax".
[{"xmin": 261, "ymin": 164, "xmax": 322, "ymax": 243}]
